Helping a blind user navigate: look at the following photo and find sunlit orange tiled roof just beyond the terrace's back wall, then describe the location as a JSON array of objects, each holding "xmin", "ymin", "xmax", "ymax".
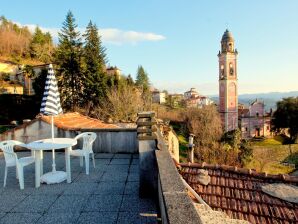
[{"xmin": 40, "ymin": 112, "xmax": 119, "ymax": 130}]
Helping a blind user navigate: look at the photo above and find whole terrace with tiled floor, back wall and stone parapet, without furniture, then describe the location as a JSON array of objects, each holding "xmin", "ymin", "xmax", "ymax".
[{"xmin": 0, "ymin": 113, "xmax": 199, "ymax": 224}]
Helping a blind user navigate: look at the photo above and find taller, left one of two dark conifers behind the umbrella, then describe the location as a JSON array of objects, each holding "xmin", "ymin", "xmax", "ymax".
[{"xmin": 55, "ymin": 11, "xmax": 84, "ymax": 110}]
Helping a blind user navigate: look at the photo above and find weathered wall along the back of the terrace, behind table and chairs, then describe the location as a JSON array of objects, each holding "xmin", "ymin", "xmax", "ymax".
[{"xmin": 0, "ymin": 120, "xmax": 138, "ymax": 153}]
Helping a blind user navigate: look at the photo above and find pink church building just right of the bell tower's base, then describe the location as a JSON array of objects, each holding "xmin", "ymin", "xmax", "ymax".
[{"xmin": 238, "ymin": 99, "xmax": 272, "ymax": 139}]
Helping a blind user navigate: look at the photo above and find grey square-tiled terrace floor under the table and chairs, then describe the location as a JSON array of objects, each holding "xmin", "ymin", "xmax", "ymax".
[{"xmin": 0, "ymin": 152, "xmax": 158, "ymax": 224}]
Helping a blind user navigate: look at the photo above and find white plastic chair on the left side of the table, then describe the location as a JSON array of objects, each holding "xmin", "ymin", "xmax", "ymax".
[{"xmin": 0, "ymin": 140, "xmax": 35, "ymax": 190}]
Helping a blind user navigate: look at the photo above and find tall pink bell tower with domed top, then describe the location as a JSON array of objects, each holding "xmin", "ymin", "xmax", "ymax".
[{"xmin": 217, "ymin": 30, "xmax": 238, "ymax": 132}]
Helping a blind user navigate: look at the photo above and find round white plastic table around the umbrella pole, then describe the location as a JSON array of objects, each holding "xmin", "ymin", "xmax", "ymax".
[{"xmin": 24, "ymin": 138, "xmax": 77, "ymax": 188}]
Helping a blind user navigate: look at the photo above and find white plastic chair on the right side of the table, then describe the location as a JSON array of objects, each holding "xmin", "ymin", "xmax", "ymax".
[{"xmin": 70, "ymin": 132, "xmax": 96, "ymax": 175}]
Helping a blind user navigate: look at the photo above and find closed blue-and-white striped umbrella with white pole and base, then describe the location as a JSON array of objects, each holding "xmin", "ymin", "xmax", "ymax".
[{"xmin": 40, "ymin": 64, "xmax": 65, "ymax": 183}]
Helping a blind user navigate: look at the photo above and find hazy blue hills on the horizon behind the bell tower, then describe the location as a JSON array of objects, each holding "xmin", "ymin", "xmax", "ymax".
[{"xmin": 210, "ymin": 91, "xmax": 298, "ymax": 111}]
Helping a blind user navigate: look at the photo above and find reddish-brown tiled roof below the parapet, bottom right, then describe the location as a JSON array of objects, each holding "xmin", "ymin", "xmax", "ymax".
[{"xmin": 180, "ymin": 163, "xmax": 298, "ymax": 224}]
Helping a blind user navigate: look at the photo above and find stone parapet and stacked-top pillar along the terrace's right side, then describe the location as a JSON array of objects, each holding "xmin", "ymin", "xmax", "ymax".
[{"xmin": 138, "ymin": 112, "xmax": 201, "ymax": 224}]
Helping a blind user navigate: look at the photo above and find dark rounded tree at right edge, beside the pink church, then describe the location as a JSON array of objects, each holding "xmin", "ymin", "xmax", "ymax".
[{"xmin": 272, "ymin": 97, "xmax": 298, "ymax": 142}]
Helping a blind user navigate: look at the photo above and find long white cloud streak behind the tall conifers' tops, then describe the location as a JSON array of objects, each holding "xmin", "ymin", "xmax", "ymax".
[{"xmin": 17, "ymin": 23, "xmax": 166, "ymax": 45}]
